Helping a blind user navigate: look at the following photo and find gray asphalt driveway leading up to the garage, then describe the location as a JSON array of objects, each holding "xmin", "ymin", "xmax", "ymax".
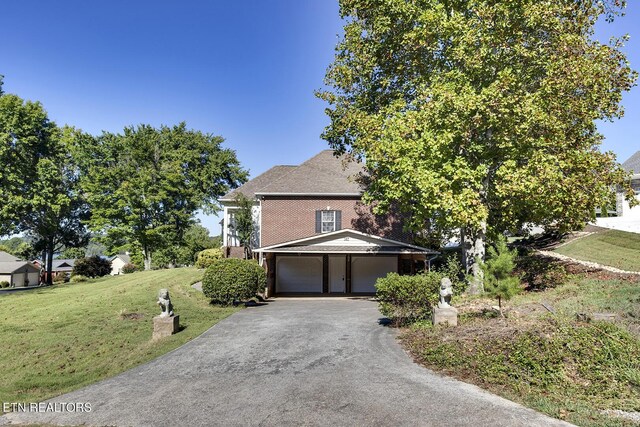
[{"xmin": 0, "ymin": 299, "xmax": 568, "ymax": 426}]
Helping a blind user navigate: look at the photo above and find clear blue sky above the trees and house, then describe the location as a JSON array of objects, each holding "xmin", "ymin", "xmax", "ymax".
[{"xmin": 0, "ymin": 0, "xmax": 640, "ymax": 233}]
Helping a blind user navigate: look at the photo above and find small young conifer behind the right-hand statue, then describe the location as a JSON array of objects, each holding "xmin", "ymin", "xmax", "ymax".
[{"xmin": 481, "ymin": 237, "xmax": 522, "ymax": 314}]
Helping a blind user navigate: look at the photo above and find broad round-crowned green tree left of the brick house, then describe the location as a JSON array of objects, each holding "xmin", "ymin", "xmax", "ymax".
[{"xmin": 75, "ymin": 123, "xmax": 247, "ymax": 269}]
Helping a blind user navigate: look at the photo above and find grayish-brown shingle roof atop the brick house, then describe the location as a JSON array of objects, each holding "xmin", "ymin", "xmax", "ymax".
[{"xmin": 222, "ymin": 150, "xmax": 363, "ymax": 200}]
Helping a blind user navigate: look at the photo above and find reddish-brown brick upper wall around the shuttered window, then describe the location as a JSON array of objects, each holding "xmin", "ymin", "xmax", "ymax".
[{"xmin": 261, "ymin": 197, "xmax": 412, "ymax": 246}]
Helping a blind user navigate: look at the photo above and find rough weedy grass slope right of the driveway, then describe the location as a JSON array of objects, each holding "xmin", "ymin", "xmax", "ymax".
[{"xmin": 401, "ymin": 273, "xmax": 640, "ymax": 427}]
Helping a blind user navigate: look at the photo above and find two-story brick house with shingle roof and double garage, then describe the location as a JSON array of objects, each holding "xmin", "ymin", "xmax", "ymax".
[{"xmin": 220, "ymin": 150, "xmax": 437, "ymax": 294}]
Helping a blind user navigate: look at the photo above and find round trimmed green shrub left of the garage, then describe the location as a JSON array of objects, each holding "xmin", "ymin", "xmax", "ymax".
[{"xmin": 202, "ymin": 258, "xmax": 267, "ymax": 305}]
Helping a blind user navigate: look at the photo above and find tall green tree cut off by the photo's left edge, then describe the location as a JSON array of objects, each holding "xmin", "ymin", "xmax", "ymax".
[{"xmin": 0, "ymin": 81, "xmax": 88, "ymax": 282}]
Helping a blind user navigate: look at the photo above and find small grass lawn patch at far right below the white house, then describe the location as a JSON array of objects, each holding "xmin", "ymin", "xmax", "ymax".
[{"xmin": 554, "ymin": 230, "xmax": 640, "ymax": 271}]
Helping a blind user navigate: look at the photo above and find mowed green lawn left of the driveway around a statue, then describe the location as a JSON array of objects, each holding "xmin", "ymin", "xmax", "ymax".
[{"xmin": 0, "ymin": 268, "xmax": 237, "ymax": 402}]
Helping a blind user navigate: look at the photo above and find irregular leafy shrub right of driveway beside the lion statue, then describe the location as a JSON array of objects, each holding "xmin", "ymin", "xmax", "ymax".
[{"xmin": 376, "ymin": 271, "xmax": 444, "ymax": 325}]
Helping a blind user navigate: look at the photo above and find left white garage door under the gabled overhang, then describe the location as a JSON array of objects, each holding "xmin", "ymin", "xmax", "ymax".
[{"xmin": 276, "ymin": 256, "xmax": 322, "ymax": 293}]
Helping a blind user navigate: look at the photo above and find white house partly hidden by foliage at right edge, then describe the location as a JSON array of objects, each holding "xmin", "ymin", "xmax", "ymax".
[{"xmin": 596, "ymin": 151, "xmax": 640, "ymax": 233}]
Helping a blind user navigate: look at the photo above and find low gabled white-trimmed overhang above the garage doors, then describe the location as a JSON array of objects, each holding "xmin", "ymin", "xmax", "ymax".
[{"xmin": 254, "ymin": 228, "xmax": 439, "ymax": 255}]
